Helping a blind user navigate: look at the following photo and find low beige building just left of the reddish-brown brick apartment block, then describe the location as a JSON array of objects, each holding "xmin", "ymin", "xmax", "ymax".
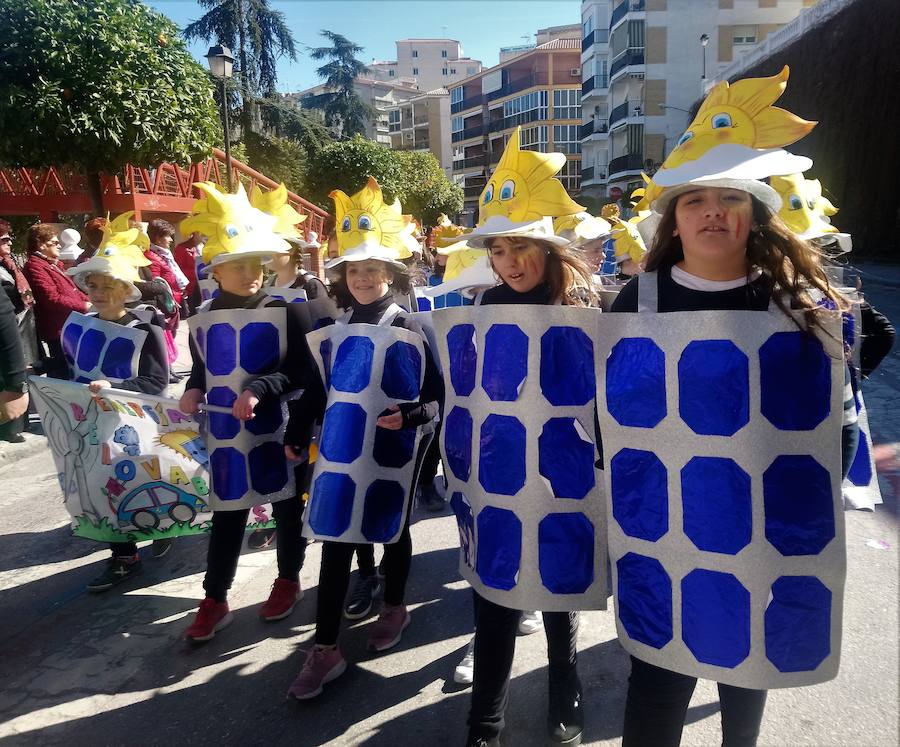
[{"xmin": 387, "ymin": 88, "xmax": 453, "ymax": 179}]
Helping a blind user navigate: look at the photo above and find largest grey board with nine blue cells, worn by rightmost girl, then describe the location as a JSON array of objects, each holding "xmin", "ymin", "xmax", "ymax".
[{"xmin": 594, "ymin": 311, "xmax": 846, "ymax": 689}]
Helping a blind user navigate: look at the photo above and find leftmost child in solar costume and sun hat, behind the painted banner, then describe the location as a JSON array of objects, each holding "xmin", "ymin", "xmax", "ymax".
[{"xmin": 60, "ymin": 237, "xmax": 171, "ymax": 592}]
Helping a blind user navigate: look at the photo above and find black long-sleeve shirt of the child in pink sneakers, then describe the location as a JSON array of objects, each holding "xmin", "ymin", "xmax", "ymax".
[{"xmin": 284, "ymin": 292, "xmax": 444, "ymax": 448}]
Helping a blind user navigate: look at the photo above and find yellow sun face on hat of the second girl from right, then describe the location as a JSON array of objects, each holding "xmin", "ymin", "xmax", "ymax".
[{"xmin": 478, "ymin": 127, "xmax": 584, "ymax": 225}]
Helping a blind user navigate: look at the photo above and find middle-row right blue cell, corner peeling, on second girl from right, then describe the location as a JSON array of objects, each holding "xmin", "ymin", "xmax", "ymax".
[{"xmin": 538, "ymin": 418, "xmax": 595, "ymax": 500}]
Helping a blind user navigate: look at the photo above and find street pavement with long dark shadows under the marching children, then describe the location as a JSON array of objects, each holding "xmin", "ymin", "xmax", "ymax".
[{"xmin": 0, "ymin": 266, "xmax": 900, "ymax": 747}]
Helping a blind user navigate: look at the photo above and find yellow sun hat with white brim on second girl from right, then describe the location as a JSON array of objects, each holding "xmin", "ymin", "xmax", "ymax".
[{"xmin": 466, "ymin": 127, "xmax": 584, "ymax": 247}]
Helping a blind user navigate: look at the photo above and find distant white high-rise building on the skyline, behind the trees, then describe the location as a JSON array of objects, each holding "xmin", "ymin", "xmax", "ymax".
[{"xmin": 368, "ymin": 39, "xmax": 482, "ymax": 91}]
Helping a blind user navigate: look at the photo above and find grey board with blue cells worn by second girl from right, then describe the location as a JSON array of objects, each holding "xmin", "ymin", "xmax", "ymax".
[{"xmin": 432, "ymin": 306, "xmax": 608, "ymax": 611}]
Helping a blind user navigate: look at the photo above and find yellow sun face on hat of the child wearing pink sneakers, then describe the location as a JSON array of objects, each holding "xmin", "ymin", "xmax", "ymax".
[{"xmin": 328, "ymin": 176, "xmax": 418, "ymax": 259}]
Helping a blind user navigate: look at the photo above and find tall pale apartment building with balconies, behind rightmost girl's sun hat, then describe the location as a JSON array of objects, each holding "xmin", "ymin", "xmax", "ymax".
[{"xmin": 581, "ymin": 0, "xmax": 817, "ymax": 199}]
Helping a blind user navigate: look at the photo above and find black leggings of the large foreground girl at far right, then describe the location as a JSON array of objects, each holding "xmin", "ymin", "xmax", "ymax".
[{"xmin": 624, "ymin": 656, "xmax": 766, "ymax": 747}]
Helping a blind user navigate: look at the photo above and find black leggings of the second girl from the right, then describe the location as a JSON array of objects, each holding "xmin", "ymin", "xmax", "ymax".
[{"xmin": 469, "ymin": 595, "xmax": 578, "ymax": 739}]
